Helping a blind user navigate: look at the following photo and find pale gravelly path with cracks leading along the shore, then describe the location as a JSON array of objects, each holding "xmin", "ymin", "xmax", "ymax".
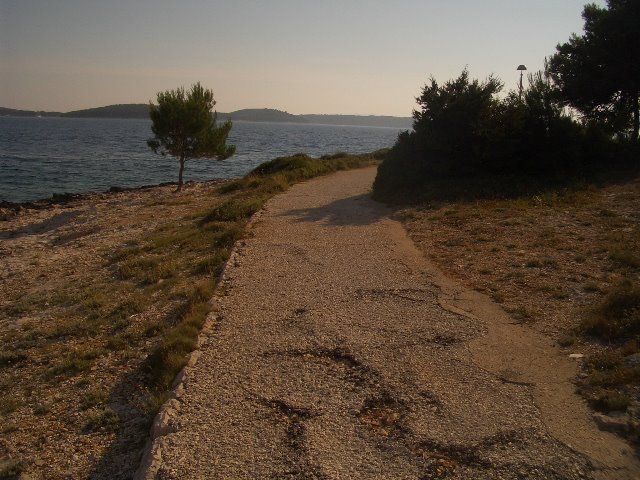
[{"xmin": 140, "ymin": 169, "xmax": 638, "ymax": 480}]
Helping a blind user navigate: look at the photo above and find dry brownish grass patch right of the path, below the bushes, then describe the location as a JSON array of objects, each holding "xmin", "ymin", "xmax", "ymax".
[{"xmin": 399, "ymin": 174, "xmax": 640, "ymax": 422}]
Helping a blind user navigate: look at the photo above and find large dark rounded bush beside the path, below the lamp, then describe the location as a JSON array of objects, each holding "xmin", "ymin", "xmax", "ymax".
[{"xmin": 374, "ymin": 70, "xmax": 631, "ymax": 200}]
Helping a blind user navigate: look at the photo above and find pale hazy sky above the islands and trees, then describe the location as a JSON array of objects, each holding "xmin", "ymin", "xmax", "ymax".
[{"xmin": 0, "ymin": 0, "xmax": 604, "ymax": 116}]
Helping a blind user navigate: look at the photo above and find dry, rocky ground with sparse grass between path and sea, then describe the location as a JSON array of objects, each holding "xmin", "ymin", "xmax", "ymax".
[{"xmin": 0, "ymin": 152, "xmax": 384, "ymax": 478}]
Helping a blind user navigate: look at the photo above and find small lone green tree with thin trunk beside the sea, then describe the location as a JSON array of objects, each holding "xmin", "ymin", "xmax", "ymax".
[{"xmin": 147, "ymin": 83, "xmax": 235, "ymax": 190}]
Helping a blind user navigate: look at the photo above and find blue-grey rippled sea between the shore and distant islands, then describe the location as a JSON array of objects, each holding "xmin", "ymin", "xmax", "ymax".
[{"xmin": 0, "ymin": 117, "xmax": 399, "ymax": 202}]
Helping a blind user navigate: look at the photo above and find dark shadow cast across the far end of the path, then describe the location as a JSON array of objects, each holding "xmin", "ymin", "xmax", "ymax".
[{"xmin": 280, "ymin": 194, "xmax": 389, "ymax": 226}]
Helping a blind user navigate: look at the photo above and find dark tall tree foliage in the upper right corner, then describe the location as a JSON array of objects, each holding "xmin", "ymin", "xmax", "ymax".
[{"xmin": 550, "ymin": 0, "xmax": 640, "ymax": 140}]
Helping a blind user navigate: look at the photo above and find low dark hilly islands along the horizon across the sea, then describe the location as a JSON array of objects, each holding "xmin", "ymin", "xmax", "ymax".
[{"xmin": 0, "ymin": 103, "xmax": 413, "ymax": 128}]
